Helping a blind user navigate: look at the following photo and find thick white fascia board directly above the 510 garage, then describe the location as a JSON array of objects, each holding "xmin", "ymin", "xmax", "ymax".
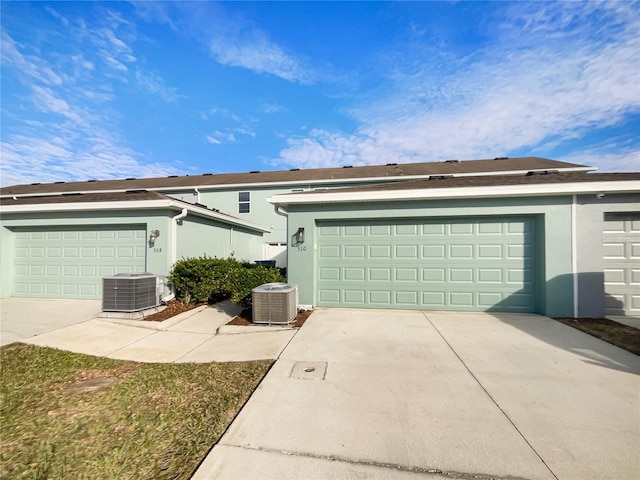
[{"xmin": 267, "ymin": 180, "xmax": 640, "ymax": 205}]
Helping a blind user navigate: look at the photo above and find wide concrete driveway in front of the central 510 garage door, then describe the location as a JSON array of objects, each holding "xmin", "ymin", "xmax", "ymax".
[{"xmin": 193, "ymin": 309, "xmax": 640, "ymax": 480}]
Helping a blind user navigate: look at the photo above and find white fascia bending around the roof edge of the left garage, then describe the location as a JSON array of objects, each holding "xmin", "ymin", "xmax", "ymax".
[{"xmin": 0, "ymin": 200, "xmax": 272, "ymax": 233}]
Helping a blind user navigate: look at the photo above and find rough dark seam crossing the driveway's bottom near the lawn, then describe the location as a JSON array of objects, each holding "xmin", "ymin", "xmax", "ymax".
[{"xmin": 219, "ymin": 443, "xmax": 528, "ymax": 480}]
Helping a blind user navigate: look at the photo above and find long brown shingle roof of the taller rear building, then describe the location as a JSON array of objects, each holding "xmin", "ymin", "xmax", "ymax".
[{"xmin": 0, "ymin": 157, "xmax": 588, "ymax": 196}]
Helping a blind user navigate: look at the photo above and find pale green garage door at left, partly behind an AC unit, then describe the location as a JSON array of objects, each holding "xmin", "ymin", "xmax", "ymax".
[{"xmin": 13, "ymin": 225, "xmax": 146, "ymax": 299}]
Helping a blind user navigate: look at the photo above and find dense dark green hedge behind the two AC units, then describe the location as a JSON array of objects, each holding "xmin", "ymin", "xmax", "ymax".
[{"xmin": 168, "ymin": 256, "xmax": 286, "ymax": 307}]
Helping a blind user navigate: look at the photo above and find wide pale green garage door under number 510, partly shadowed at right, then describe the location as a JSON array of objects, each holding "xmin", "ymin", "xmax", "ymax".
[{"xmin": 317, "ymin": 217, "xmax": 536, "ymax": 312}]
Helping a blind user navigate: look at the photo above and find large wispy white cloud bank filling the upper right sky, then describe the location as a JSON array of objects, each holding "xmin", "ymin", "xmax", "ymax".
[{"xmin": 275, "ymin": 2, "xmax": 640, "ymax": 169}]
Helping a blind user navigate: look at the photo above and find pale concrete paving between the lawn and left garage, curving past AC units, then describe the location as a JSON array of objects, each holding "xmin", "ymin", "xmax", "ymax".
[{"xmin": 0, "ymin": 299, "xmax": 297, "ymax": 363}]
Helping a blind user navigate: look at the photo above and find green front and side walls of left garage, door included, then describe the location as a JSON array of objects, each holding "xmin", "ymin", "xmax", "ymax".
[{"xmin": 0, "ymin": 209, "xmax": 263, "ymax": 298}]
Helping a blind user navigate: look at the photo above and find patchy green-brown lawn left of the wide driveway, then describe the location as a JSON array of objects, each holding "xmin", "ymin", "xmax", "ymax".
[{"xmin": 0, "ymin": 344, "xmax": 272, "ymax": 479}]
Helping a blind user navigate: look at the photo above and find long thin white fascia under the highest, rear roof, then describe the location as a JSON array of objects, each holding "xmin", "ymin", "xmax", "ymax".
[{"xmin": 2, "ymin": 167, "xmax": 596, "ymax": 198}]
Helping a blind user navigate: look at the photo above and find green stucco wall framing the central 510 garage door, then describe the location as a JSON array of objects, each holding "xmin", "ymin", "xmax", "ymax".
[{"xmin": 288, "ymin": 196, "xmax": 573, "ymax": 316}]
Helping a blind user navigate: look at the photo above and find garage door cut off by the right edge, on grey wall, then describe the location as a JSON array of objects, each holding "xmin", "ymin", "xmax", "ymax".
[{"xmin": 603, "ymin": 213, "xmax": 640, "ymax": 315}]
